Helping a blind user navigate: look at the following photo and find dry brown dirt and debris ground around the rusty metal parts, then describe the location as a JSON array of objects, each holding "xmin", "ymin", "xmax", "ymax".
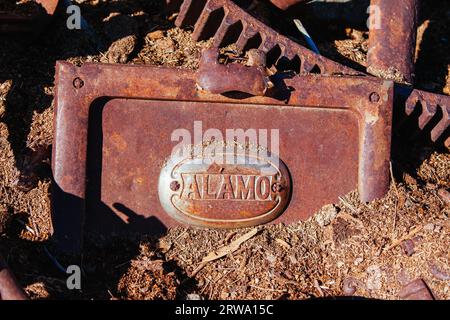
[{"xmin": 0, "ymin": 0, "xmax": 450, "ymax": 299}]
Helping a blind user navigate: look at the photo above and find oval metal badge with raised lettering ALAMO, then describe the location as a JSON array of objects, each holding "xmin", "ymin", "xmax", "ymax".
[{"xmin": 158, "ymin": 146, "xmax": 291, "ymax": 228}]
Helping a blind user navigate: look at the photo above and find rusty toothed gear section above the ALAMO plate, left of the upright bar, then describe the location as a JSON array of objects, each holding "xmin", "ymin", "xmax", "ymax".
[{"xmin": 167, "ymin": 0, "xmax": 363, "ymax": 75}]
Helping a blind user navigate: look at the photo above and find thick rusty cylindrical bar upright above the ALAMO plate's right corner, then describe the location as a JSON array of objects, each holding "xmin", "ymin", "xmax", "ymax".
[{"xmin": 367, "ymin": 0, "xmax": 419, "ymax": 84}]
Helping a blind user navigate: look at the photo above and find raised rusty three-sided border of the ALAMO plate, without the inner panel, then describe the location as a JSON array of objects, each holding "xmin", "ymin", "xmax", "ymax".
[{"xmin": 52, "ymin": 62, "xmax": 393, "ymax": 252}]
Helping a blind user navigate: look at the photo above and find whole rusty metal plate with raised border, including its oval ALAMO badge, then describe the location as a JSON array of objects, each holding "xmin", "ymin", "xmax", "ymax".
[{"xmin": 52, "ymin": 62, "xmax": 393, "ymax": 250}]
